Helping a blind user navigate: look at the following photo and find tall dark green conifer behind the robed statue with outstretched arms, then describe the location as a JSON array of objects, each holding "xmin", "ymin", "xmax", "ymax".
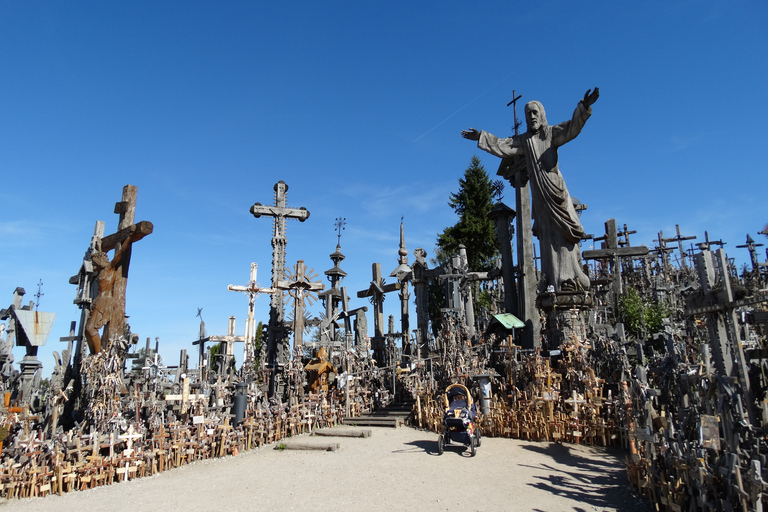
[{"xmin": 436, "ymin": 155, "xmax": 499, "ymax": 272}]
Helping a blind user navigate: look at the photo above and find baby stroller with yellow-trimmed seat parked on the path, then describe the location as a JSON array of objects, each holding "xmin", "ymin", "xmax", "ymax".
[{"xmin": 437, "ymin": 384, "xmax": 480, "ymax": 457}]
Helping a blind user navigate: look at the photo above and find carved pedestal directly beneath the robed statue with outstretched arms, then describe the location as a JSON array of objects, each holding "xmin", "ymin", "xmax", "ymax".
[{"xmin": 539, "ymin": 292, "xmax": 593, "ymax": 350}]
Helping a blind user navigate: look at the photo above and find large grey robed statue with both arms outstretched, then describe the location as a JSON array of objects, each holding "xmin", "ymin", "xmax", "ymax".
[{"xmin": 461, "ymin": 87, "xmax": 600, "ymax": 292}]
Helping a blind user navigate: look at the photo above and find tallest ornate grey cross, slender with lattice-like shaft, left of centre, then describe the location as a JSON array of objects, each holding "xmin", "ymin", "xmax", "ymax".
[{"xmin": 251, "ymin": 180, "xmax": 309, "ymax": 397}]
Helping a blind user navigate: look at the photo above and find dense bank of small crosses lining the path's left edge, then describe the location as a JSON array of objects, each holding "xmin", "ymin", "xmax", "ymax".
[{"xmin": 0, "ymin": 328, "xmax": 386, "ymax": 498}]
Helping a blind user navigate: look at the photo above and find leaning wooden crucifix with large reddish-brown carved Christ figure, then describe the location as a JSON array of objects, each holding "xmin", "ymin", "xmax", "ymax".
[{"xmin": 85, "ymin": 185, "xmax": 153, "ymax": 354}]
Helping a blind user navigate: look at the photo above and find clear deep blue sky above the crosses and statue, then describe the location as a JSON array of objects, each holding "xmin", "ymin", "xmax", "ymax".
[{"xmin": 0, "ymin": 0, "xmax": 768, "ymax": 374}]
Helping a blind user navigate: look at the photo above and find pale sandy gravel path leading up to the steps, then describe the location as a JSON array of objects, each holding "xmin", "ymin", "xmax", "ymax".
[{"xmin": 0, "ymin": 427, "xmax": 649, "ymax": 512}]
